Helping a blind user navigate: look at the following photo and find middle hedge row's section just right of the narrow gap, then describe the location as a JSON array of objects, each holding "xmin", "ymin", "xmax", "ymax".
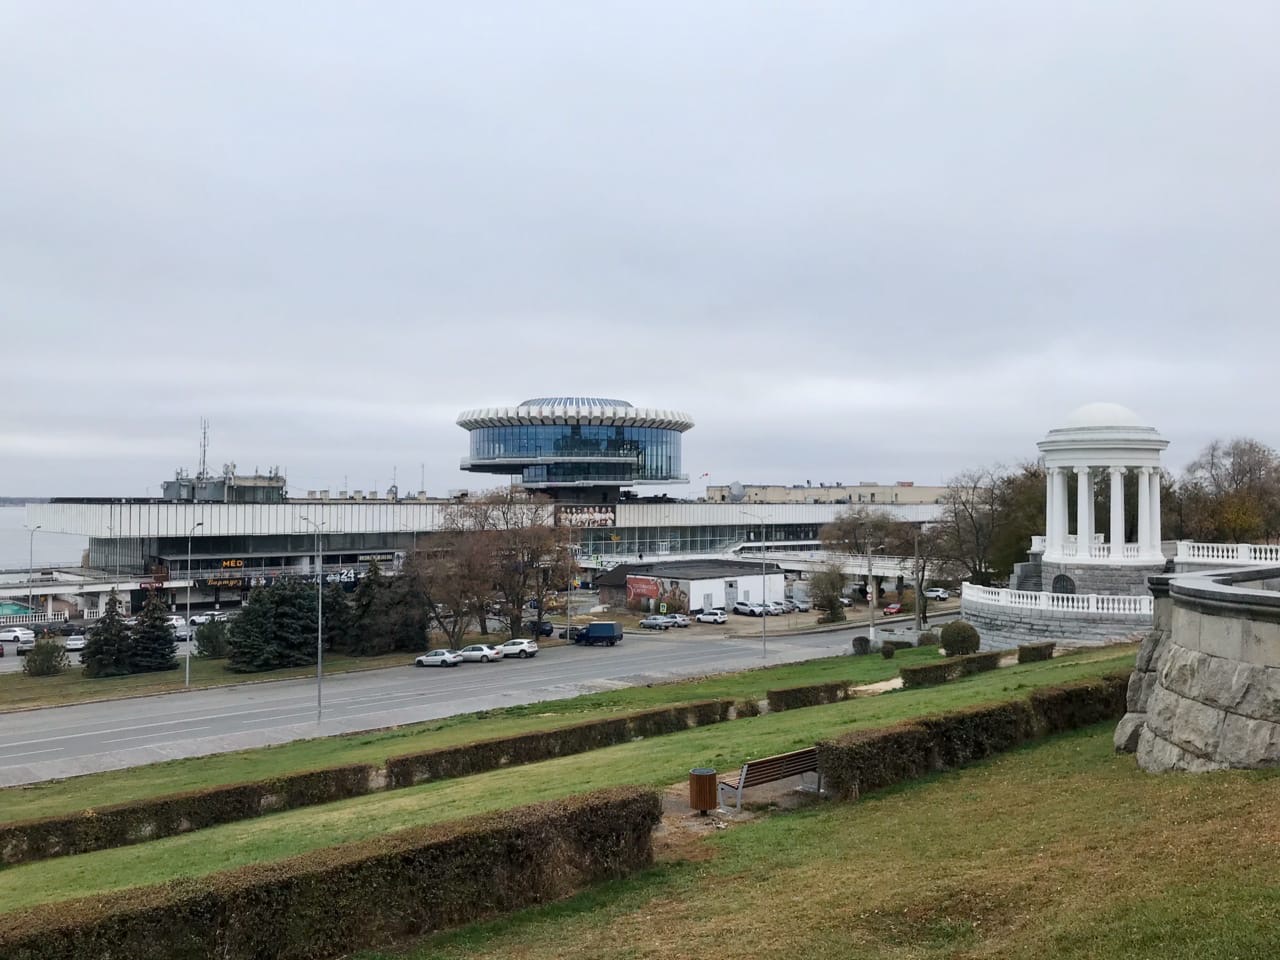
[{"xmin": 387, "ymin": 700, "xmax": 727, "ymax": 790}]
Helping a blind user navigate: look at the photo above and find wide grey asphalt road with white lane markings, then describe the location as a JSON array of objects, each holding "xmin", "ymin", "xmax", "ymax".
[{"xmin": 0, "ymin": 616, "xmax": 952, "ymax": 786}]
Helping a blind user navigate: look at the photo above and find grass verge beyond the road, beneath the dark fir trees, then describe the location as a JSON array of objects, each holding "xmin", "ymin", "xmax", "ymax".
[{"xmin": 0, "ymin": 652, "xmax": 413, "ymax": 713}]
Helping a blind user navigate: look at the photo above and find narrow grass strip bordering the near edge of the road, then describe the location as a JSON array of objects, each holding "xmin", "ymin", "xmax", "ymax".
[{"xmin": 0, "ymin": 649, "xmax": 942, "ymax": 822}]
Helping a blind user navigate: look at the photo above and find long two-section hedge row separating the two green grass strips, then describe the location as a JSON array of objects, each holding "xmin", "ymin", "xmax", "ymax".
[{"xmin": 0, "ymin": 700, "xmax": 730, "ymax": 864}]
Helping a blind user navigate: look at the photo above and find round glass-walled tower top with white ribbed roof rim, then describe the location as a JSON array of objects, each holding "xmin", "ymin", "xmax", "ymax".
[{"xmin": 458, "ymin": 397, "xmax": 694, "ymax": 503}]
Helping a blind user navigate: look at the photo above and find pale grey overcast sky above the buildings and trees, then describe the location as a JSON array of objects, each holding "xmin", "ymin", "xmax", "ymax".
[{"xmin": 0, "ymin": 0, "xmax": 1280, "ymax": 504}]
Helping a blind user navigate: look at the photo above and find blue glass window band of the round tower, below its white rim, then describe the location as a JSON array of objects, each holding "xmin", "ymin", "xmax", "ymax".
[{"xmin": 470, "ymin": 424, "xmax": 681, "ymax": 484}]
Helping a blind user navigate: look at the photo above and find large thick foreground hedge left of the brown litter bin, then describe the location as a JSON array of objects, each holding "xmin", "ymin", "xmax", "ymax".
[{"xmin": 0, "ymin": 787, "xmax": 662, "ymax": 960}]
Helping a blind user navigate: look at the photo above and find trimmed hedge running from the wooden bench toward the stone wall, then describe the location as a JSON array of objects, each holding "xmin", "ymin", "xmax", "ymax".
[{"xmin": 818, "ymin": 675, "xmax": 1129, "ymax": 799}]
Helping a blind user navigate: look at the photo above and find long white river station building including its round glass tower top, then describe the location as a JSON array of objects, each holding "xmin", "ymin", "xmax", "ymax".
[{"xmin": 17, "ymin": 397, "xmax": 941, "ymax": 616}]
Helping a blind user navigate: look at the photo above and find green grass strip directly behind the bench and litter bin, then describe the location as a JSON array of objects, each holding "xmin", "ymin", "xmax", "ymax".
[{"xmin": 0, "ymin": 650, "xmax": 1133, "ymax": 911}]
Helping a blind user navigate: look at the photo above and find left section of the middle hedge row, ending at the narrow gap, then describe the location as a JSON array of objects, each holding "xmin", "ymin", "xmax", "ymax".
[{"xmin": 0, "ymin": 763, "xmax": 379, "ymax": 864}]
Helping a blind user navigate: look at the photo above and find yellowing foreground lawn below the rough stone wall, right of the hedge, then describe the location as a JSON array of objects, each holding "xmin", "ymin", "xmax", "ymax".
[{"xmin": 356, "ymin": 727, "xmax": 1280, "ymax": 960}]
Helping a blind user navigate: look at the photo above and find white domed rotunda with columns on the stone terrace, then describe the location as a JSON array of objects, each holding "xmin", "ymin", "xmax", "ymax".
[{"xmin": 1032, "ymin": 403, "xmax": 1169, "ymax": 594}]
